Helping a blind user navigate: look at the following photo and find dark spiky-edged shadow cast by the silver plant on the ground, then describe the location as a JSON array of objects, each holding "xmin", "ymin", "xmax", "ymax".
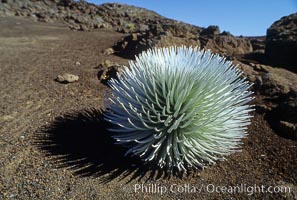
[{"xmin": 34, "ymin": 109, "xmax": 184, "ymax": 183}]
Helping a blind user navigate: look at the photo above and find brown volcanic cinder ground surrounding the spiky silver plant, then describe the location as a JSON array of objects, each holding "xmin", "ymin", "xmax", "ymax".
[{"xmin": 0, "ymin": 17, "xmax": 297, "ymax": 200}]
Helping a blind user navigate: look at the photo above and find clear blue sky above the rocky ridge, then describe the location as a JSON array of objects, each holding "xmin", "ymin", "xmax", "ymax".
[{"xmin": 82, "ymin": 0, "xmax": 297, "ymax": 36}]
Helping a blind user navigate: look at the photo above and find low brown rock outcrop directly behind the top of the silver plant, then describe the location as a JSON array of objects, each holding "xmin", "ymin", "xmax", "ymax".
[{"xmin": 114, "ymin": 23, "xmax": 253, "ymax": 59}]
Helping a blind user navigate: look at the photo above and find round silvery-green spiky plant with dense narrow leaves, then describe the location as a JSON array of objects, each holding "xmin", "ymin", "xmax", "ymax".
[{"xmin": 105, "ymin": 46, "xmax": 253, "ymax": 171}]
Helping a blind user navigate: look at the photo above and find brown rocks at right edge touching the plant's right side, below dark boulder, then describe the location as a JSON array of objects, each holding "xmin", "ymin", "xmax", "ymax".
[{"xmin": 235, "ymin": 61, "xmax": 297, "ymax": 139}]
